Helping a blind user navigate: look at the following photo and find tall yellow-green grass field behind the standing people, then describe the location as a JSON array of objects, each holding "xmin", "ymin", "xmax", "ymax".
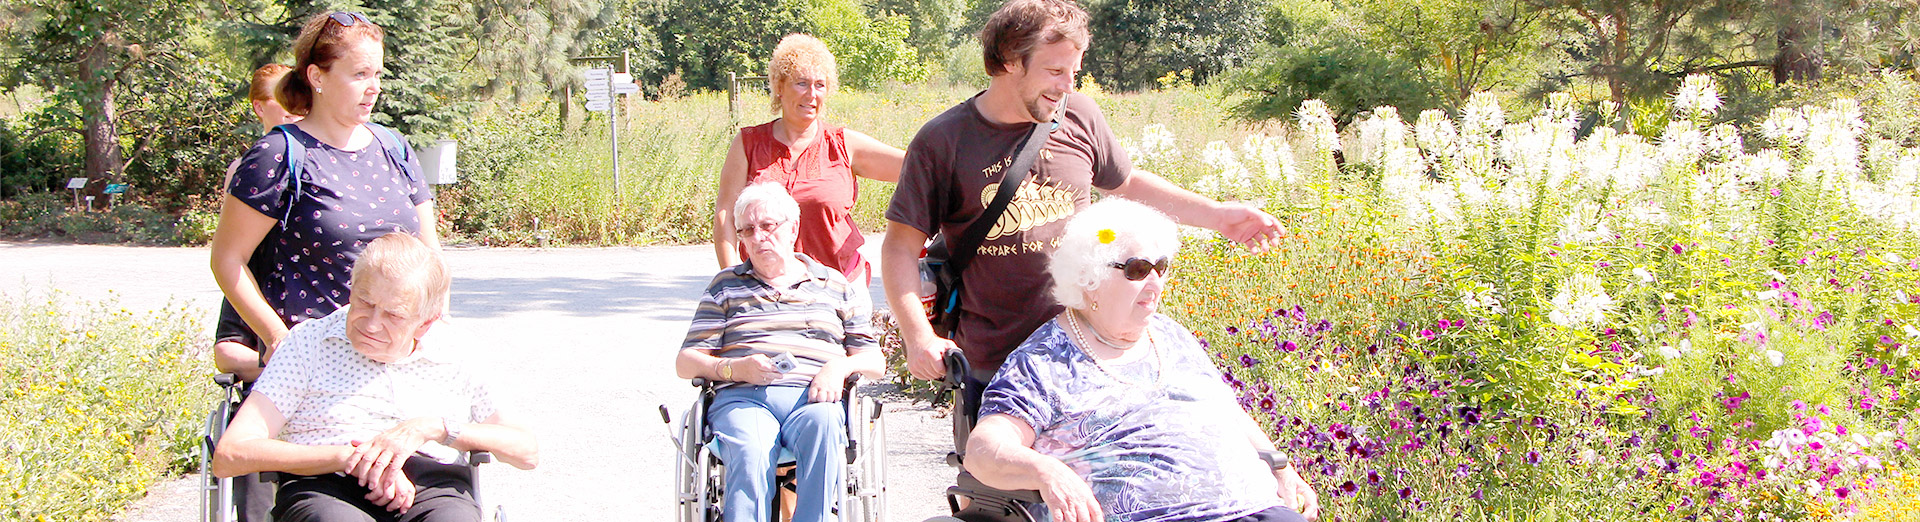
[{"xmin": 440, "ymin": 84, "xmax": 1254, "ymax": 246}]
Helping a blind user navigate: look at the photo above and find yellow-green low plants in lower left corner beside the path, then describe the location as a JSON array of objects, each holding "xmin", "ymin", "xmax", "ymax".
[{"xmin": 0, "ymin": 294, "xmax": 215, "ymax": 520}]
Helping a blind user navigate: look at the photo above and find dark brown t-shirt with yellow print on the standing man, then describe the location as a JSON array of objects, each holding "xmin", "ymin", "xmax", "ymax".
[{"xmin": 887, "ymin": 94, "xmax": 1133, "ymax": 370}]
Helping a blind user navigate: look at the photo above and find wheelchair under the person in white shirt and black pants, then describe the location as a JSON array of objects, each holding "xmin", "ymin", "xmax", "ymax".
[{"xmin": 194, "ymin": 374, "xmax": 507, "ymax": 522}]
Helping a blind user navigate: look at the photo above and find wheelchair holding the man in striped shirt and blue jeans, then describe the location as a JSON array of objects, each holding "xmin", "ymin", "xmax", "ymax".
[{"xmin": 660, "ymin": 376, "xmax": 887, "ymax": 522}]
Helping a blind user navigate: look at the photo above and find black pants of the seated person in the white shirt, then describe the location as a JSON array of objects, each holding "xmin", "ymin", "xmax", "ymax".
[{"xmin": 273, "ymin": 457, "xmax": 480, "ymax": 522}]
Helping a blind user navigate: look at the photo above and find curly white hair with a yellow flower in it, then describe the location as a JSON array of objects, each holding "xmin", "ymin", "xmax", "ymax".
[{"xmin": 1046, "ymin": 198, "xmax": 1181, "ymax": 309}]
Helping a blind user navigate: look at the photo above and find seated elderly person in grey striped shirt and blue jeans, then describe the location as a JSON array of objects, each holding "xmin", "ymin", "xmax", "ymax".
[{"xmin": 674, "ymin": 184, "xmax": 885, "ymax": 522}]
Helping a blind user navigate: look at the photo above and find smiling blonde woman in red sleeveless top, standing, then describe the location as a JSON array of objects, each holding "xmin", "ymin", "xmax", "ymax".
[{"xmin": 714, "ymin": 35, "xmax": 906, "ymax": 284}]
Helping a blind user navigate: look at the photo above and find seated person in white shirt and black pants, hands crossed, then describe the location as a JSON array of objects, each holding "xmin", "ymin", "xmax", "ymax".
[{"xmin": 211, "ymin": 234, "xmax": 538, "ymax": 522}]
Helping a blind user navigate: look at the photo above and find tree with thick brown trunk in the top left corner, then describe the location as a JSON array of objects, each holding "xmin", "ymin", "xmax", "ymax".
[{"xmin": 6, "ymin": 0, "xmax": 198, "ymax": 196}]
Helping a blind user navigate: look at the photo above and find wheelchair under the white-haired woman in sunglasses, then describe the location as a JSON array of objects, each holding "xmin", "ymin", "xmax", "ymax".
[{"xmin": 924, "ymin": 349, "xmax": 1288, "ymax": 522}]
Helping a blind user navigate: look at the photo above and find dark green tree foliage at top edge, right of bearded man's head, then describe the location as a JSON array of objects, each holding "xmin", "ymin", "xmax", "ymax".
[{"xmin": 1085, "ymin": 0, "xmax": 1265, "ymax": 90}]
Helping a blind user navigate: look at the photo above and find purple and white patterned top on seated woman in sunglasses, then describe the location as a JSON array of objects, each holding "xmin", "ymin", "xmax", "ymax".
[{"xmin": 979, "ymin": 313, "xmax": 1281, "ymax": 522}]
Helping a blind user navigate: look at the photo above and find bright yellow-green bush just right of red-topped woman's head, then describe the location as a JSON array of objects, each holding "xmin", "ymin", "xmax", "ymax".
[{"xmin": 806, "ymin": 0, "xmax": 931, "ymax": 88}]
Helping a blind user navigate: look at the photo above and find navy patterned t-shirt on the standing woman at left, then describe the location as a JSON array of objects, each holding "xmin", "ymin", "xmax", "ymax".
[{"xmin": 227, "ymin": 127, "xmax": 434, "ymax": 326}]
